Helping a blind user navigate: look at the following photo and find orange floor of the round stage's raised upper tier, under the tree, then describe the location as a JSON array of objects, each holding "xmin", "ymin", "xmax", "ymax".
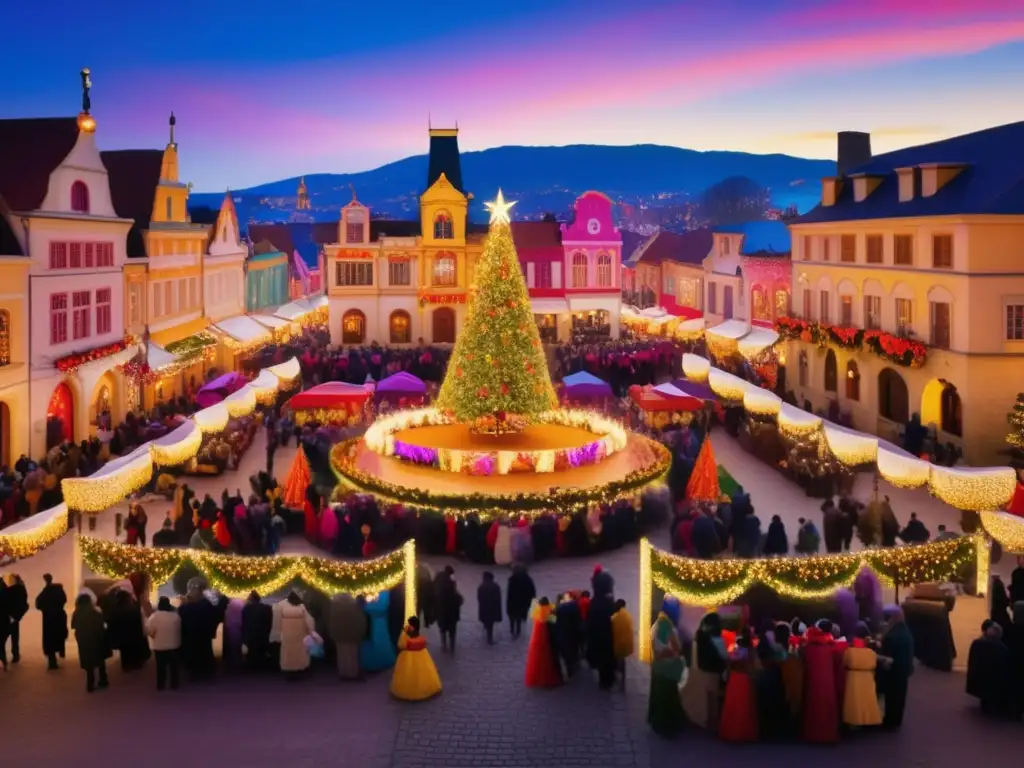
[{"xmin": 394, "ymin": 424, "xmax": 599, "ymax": 452}]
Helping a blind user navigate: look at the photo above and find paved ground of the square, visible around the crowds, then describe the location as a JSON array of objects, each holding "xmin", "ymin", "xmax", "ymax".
[{"xmin": 0, "ymin": 433, "xmax": 1022, "ymax": 768}]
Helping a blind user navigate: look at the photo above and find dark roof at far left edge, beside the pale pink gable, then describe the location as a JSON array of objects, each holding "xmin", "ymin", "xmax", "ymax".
[{"xmin": 0, "ymin": 118, "xmax": 78, "ymax": 211}]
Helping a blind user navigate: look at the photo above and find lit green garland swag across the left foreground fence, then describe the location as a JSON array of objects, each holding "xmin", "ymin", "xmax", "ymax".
[{"xmin": 78, "ymin": 537, "xmax": 406, "ymax": 597}]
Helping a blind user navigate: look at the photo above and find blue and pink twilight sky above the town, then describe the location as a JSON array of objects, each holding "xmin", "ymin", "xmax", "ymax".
[{"xmin": 0, "ymin": 0, "xmax": 1024, "ymax": 191}]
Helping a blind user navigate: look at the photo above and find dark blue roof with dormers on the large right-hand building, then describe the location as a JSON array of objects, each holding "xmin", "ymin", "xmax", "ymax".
[{"xmin": 794, "ymin": 122, "xmax": 1024, "ymax": 224}]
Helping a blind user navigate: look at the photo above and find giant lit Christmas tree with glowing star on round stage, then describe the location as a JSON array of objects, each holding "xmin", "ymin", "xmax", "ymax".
[{"xmin": 437, "ymin": 189, "xmax": 558, "ymax": 422}]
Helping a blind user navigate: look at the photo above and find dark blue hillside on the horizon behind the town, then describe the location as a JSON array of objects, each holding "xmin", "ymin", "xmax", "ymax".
[{"xmin": 190, "ymin": 144, "xmax": 835, "ymax": 225}]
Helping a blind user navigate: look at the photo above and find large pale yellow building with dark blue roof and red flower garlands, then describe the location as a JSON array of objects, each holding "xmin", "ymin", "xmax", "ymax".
[{"xmin": 786, "ymin": 123, "xmax": 1024, "ymax": 465}]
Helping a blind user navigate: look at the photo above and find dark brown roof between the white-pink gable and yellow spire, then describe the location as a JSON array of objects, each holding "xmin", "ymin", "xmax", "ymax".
[{"xmin": 99, "ymin": 150, "xmax": 164, "ymax": 258}]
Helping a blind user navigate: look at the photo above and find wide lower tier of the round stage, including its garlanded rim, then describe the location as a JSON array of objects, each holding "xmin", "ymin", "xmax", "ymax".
[{"xmin": 331, "ymin": 436, "xmax": 671, "ymax": 518}]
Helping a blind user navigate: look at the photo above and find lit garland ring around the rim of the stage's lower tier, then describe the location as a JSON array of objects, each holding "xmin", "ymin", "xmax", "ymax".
[{"xmin": 331, "ymin": 438, "xmax": 672, "ymax": 520}]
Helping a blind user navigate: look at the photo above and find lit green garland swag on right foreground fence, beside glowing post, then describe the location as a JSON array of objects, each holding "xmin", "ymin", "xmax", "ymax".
[{"xmin": 650, "ymin": 536, "xmax": 986, "ymax": 605}]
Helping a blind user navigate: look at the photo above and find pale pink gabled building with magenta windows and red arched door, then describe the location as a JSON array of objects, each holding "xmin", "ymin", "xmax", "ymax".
[{"xmin": 0, "ymin": 109, "xmax": 137, "ymax": 457}]
